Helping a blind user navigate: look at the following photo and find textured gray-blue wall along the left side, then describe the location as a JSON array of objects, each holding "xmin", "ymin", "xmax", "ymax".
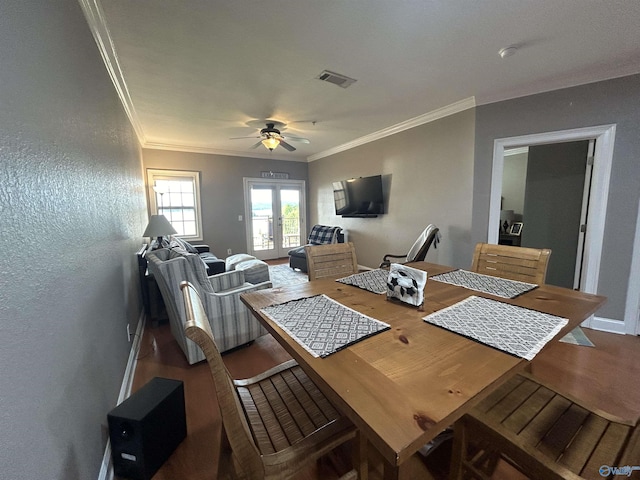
[{"xmin": 0, "ymin": 0, "xmax": 146, "ymax": 480}]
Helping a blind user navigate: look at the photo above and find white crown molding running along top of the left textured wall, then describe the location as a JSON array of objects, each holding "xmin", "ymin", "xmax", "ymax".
[{"xmin": 78, "ymin": 0, "xmax": 146, "ymax": 146}]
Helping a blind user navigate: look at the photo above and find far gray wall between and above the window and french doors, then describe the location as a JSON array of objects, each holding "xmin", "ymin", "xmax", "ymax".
[{"xmin": 143, "ymin": 149, "xmax": 308, "ymax": 258}]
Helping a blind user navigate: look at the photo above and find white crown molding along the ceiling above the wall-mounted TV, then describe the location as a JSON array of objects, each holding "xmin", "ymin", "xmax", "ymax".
[{"xmin": 307, "ymin": 97, "xmax": 476, "ymax": 162}]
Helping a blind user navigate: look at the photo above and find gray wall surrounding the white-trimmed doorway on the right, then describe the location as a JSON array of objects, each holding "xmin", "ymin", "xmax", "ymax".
[{"xmin": 472, "ymin": 75, "xmax": 640, "ymax": 320}]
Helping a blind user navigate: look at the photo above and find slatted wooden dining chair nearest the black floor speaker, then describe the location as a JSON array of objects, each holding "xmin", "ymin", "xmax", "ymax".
[{"xmin": 180, "ymin": 281, "xmax": 367, "ymax": 480}]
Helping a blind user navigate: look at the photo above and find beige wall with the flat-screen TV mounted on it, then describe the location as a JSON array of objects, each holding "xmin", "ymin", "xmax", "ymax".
[{"xmin": 308, "ymin": 110, "xmax": 475, "ymax": 267}]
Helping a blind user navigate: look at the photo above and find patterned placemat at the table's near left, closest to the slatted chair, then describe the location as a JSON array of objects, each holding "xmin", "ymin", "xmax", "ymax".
[{"xmin": 261, "ymin": 295, "xmax": 390, "ymax": 357}]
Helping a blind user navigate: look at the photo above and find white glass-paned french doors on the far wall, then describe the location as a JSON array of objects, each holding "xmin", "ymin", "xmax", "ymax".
[{"xmin": 244, "ymin": 178, "xmax": 306, "ymax": 260}]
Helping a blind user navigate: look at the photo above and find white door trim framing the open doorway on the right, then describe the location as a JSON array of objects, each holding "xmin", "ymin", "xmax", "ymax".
[{"xmin": 487, "ymin": 124, "xmax": 616, "ymax": 327}]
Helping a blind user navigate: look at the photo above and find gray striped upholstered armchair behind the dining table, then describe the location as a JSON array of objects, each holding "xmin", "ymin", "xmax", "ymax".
[{"xmin": 147, "ymin": 248, "xmax": 271, "ymax": 364}]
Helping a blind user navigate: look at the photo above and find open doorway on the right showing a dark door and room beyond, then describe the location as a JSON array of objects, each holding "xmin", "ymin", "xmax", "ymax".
[{"xmin": 500, "ymin": 140, "xmax": 595, "ymax": 289}]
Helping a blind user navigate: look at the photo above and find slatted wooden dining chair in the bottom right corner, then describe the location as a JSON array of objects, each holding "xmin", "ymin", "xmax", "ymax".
[{"xmin": 449, "ymin": 373, "xmax": 640, "ymax": 480}]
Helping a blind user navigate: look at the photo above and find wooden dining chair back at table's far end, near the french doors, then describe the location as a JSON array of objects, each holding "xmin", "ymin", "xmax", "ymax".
[{"xmin": 305, "ymin": 242, "xmax": 358, "ymax": 282}]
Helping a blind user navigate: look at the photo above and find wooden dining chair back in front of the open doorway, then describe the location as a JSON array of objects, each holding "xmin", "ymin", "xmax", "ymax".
[{"xmin": 471, "ymin": 243, "xmax": 551, "ymax": 285}]
